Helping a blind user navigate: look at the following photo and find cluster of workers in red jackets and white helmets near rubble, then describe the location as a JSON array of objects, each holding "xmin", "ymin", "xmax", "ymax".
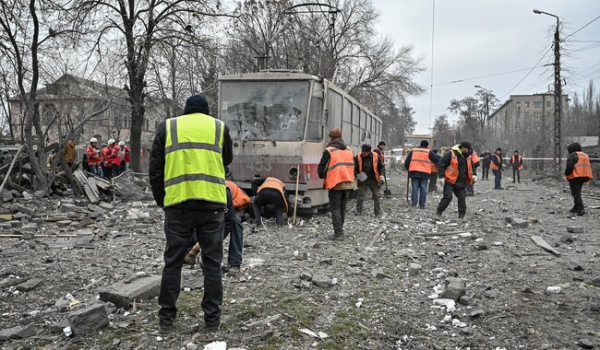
[{"xmin": 83, "ymin": 137, "xmax": 131, "ymax": 179}]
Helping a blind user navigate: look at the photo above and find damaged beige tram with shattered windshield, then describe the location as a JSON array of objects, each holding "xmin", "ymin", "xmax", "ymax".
[{"xmin": 219, "ymin": 70, "xmax": 382, "ymax": 213}]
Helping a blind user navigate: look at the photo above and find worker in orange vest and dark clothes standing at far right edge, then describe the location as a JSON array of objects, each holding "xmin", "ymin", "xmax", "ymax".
[{"xmin": 565, "ymin": 142, "xmax": 594, "ymax": 216}]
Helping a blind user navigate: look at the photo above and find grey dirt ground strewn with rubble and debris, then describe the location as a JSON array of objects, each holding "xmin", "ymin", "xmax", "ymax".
[{"xmin": 0, "ymin": 168, "xmax": 600, "ymax": 350}]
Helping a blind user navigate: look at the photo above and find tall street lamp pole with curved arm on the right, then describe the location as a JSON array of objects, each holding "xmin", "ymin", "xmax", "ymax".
[{"xmin": 533, "ymin": 9, "xmax": 562, "ymax": 171}]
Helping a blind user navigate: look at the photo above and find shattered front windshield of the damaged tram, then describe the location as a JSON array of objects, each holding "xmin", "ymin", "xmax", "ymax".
[{"xmin": 220, "ymin": 81, "xmax": 310, "ymax": 141}]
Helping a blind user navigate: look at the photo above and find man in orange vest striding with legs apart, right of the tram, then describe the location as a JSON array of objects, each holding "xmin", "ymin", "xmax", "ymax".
[{"xmin": 435, "ymin": 141, "xmax": 477, "ymax": 220}]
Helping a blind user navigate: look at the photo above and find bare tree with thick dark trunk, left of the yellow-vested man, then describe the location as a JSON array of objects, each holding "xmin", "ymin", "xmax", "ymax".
[{"xmin": 74, "ymin": 0, "xmax": 230, "ymax": 171}]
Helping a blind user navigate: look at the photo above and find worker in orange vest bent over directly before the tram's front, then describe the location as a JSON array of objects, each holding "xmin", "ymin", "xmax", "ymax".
[{"xmin": 252, "ymin": 177, "xmax": 289, "ymax": 226}]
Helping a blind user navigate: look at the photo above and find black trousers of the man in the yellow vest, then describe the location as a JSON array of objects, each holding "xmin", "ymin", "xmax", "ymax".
[{"xmin": 158, "ymin": 208, "xmax": 225, "ymax": 327}]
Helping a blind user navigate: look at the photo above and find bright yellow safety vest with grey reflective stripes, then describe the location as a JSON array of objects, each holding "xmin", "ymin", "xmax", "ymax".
[{"xmin": 164, "ymin": 113, "xmax": 227, "ymax": 207}]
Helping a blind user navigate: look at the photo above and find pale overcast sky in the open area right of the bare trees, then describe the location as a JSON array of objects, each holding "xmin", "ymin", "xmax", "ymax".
[{"xmin": 373, "ymin": 0, "xmax": 600, "ymax": 133}]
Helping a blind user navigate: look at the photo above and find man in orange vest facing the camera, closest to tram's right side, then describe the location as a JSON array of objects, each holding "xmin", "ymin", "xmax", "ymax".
[{"xmin": 354, "ymin": 144, "xmax": 385, "ymax": 216}]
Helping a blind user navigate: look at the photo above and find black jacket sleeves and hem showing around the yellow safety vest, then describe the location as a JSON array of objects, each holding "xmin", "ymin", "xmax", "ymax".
[{"xmin": 148, "ymin": 115, "xmax": 233, "ymax": 210}]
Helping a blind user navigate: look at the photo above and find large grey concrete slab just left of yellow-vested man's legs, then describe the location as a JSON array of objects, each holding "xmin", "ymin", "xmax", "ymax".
[{"xmin": 100, "ymin": 275, "xmax": 161, "ymax": 309}]
